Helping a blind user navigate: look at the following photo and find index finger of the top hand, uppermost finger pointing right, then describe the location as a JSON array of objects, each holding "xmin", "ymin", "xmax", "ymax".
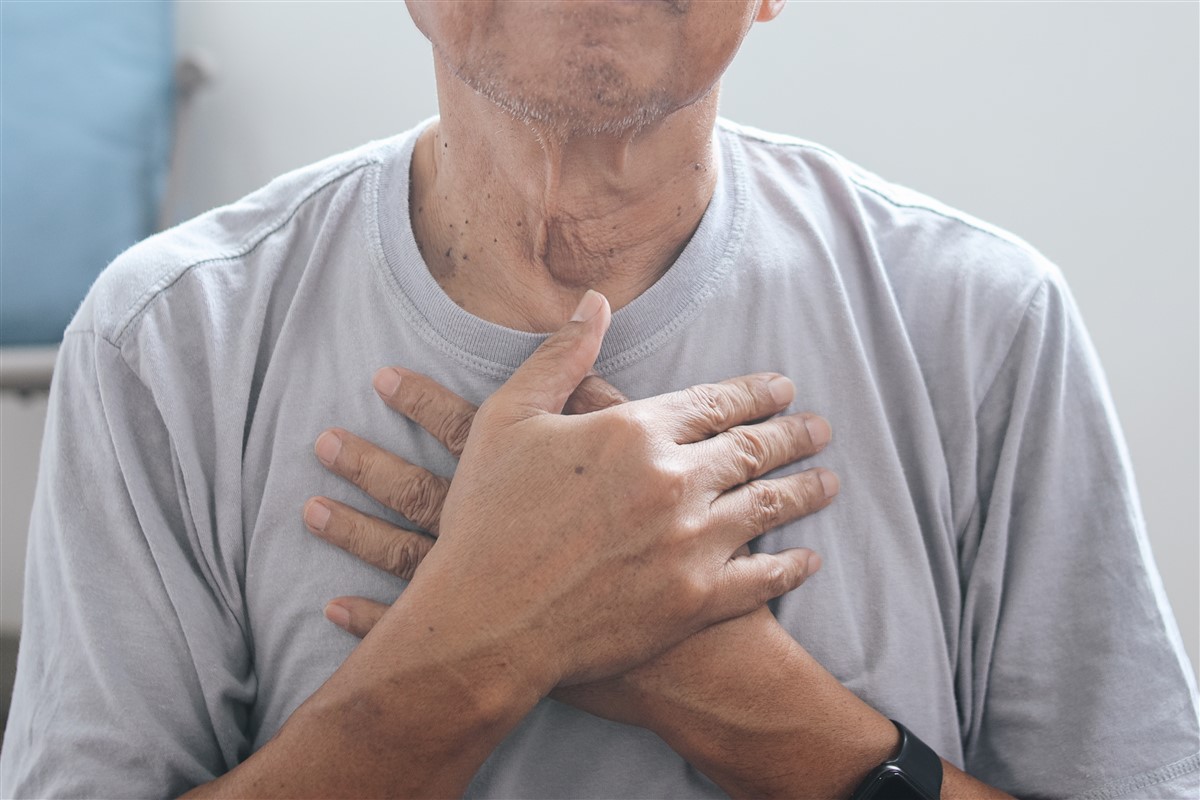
[{"xmin": 637, "ymin": 372, "xmax": 796, "ymax": 444}]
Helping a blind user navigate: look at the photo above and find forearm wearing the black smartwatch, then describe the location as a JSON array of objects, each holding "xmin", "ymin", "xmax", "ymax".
[{"xmin": 650, "ymin": 628, "xmax": 1008, "ymax": 799}]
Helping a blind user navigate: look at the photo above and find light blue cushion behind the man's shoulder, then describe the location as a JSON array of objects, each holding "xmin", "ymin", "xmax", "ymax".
[{"xmin": 0, "ymin": 1, "xmax": 174, "ymax": 344}]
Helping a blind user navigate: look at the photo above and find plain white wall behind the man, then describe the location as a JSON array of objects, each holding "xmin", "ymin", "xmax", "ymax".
[{"xmin": 4, "ymin": 2, "xmax": 1200, "ymax": 681}]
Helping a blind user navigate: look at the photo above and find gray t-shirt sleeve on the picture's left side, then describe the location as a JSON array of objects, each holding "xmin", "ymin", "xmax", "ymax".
[{"xmin": 0, "ymin": 331, "xmax": 254, "ymax": 798}]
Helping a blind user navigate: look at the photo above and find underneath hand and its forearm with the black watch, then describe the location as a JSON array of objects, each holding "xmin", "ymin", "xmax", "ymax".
[{"xmin": 305, "ymin": 371, "xmax": 1008, "ymax": 800}]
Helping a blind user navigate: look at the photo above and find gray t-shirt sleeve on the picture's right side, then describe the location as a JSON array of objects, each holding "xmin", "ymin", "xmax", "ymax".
[{"xmin": 958, "ymin": 275, "xmax": 1200, "ymax": 800}]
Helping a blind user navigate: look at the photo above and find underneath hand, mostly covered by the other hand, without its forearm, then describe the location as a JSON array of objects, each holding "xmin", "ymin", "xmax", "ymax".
[{"xmin": 305, "ymin": 368, "xmax": 836, "ymax": 728}]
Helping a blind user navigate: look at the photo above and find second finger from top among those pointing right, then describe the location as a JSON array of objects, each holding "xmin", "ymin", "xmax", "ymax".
[{"xmin": 695, "ymin": 414, "xmax": 832, "ymax": 489}]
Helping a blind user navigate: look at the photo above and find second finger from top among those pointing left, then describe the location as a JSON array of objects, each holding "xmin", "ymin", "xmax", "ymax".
[{"xmin": 314, "ymin": 428, "xmax": 450, "ymax": 536}]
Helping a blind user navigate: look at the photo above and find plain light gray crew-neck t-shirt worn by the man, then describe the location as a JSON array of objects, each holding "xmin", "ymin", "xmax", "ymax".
[{"xmin": 0, "ymin": 122, "xmax": 1200, "ymax": 799}]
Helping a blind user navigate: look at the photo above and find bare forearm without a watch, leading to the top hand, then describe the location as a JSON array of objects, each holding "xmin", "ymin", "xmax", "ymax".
[{"xmin": 187, "ymin": 592, "xmax": 541, "ymax": 798}]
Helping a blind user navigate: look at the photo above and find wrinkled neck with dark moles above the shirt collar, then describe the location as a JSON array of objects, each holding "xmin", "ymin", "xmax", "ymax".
[{"xmin": 409, "ymin": 122, "xmax": 713, "ymax": 332}]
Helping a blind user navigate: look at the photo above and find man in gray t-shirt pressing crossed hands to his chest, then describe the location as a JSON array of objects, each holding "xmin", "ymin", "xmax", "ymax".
[{"xmin": 4, "ymin": 1, "xmax": 1200, "ymax": 798}]
